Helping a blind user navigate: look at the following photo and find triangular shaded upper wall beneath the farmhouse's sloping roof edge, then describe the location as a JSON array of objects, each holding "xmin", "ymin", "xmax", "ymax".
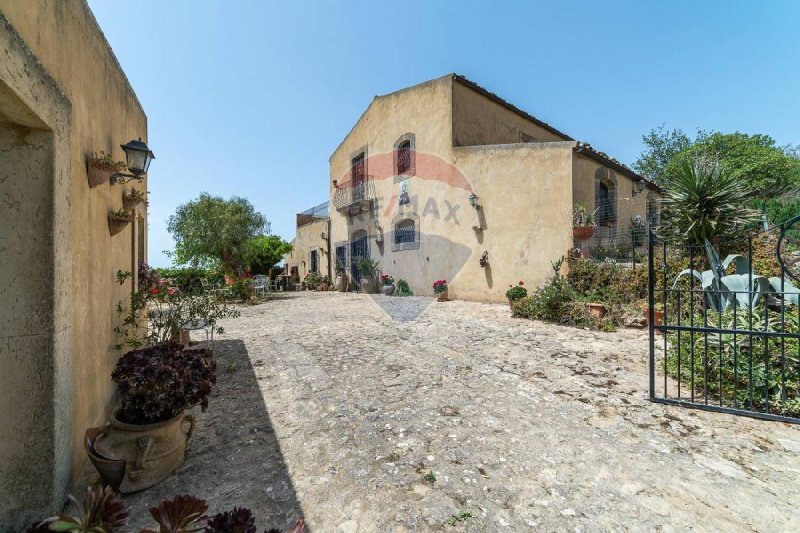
[{"xmin": 453, "ymin": 80, "xmax": 566, "ymax": 146}]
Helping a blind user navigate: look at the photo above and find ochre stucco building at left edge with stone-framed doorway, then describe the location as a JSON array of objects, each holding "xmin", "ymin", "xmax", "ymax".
[{"xmin": 0, "ymin": 0, "xmax": 147, "ymax": 531}]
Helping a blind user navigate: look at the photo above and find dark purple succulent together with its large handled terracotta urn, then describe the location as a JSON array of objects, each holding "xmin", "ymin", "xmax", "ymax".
[{"xmin": 84, "ymin": 342, "xmax": 217, "ymax": 493}]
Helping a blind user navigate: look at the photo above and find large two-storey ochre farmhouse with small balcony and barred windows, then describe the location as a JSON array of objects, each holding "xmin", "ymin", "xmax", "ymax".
[{"xmin": 330, "ymin": 74, "xmax": 656, "ymax": 301}]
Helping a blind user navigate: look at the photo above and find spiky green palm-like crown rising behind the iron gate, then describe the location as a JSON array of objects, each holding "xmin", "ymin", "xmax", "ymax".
[{"xmin": 661, "ymin": 157, "xmax": 760, "ymax": 246}]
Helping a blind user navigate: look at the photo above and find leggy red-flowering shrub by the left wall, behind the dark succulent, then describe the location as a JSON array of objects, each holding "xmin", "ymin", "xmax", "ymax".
[{"xmin": 112, "ymin": 263, "xmax": 239, "ymax": 350}]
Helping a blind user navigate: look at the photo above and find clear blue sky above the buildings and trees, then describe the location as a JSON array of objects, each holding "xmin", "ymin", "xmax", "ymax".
[{"xmin": 89, "ymin": 0, "xmax": 800, "ymax": 266}]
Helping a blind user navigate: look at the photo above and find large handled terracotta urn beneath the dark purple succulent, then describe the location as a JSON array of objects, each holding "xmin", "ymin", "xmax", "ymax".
[{"xmin": 84, "ymin": 411, "xmax": 194, "ymax": 493}]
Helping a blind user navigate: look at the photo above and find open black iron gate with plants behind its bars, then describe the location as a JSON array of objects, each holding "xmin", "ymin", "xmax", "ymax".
[{"xmin": 648, "ymin": 216, "xmax": 800, "ymax": 423}]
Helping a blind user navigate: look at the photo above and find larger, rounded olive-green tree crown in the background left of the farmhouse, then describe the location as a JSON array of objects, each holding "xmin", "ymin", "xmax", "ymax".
[{"xmin": 167, "ymin": 193, "xmax": 269, "ymax": 273}]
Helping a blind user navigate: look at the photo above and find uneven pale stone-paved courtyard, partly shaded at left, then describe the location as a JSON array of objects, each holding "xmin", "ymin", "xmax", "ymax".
[{"xmin": 120, "ymin": 293, "xmax": 800, "ymax": 532}]
